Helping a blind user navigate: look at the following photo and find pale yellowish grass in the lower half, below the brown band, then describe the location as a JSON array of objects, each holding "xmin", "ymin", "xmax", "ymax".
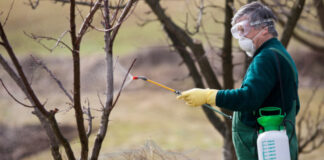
[{"xmin": 0, "ymin": 88, "xmax": 316, "ymax": 160}]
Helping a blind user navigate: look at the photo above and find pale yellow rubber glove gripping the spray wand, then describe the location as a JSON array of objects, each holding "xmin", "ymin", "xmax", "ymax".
[{"xmin": 177, "ymin": 88, "xmax": 218, "ymax": 107}]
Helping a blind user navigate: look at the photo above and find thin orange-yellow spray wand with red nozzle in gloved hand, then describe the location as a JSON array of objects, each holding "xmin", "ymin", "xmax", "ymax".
[{"xmin": 133, "ymin": 76, "xmax": 232, "ymax": 119}]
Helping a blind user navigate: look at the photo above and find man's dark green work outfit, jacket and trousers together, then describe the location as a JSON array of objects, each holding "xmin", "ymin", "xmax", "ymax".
[{"xmin": 216, "ymin": 38, "xmax": 299, "ymax": 159}]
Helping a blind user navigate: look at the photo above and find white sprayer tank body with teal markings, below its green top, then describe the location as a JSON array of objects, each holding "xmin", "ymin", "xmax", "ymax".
[{"xmin": 257, "ymin": 130, "xmax": 290, "ymax": 160}]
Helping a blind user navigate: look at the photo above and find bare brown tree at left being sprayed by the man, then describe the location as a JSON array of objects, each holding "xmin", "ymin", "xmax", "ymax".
[{"xmin": 0, "ymin": 0, "xmax": 137, "ymax": 160}]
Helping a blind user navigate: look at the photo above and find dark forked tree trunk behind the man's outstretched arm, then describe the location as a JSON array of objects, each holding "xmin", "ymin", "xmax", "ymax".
[{"xmin": 145, "ymin": 0, "xmax": 235, "ymax": 160}]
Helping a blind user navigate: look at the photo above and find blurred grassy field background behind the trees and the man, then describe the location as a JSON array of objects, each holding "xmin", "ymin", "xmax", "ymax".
[{"xmin": 0, "ymin": 0, "xmax": 324, "ymax": 160}]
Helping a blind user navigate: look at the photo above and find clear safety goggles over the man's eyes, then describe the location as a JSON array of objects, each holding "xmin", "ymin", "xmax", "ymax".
[{"xmin": 231, "ymin": 20, "xmax": 251, "ymax": 39}]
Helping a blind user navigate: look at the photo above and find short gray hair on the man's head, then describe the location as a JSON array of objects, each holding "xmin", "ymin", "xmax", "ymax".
[{"xmin": 232, "ymin": 2, "xmax": 278, "ymax": 37}]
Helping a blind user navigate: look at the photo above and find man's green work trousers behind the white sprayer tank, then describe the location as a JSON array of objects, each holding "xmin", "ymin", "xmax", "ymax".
[{"xmin": 232, "ymin": 104, "xmax": 298, "ymax": 160}]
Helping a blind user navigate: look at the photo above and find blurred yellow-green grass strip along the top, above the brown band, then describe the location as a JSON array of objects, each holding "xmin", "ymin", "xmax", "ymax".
[{"xmin": 0, "ymin": 0, "xmax": 314, "ymax": 56}]
